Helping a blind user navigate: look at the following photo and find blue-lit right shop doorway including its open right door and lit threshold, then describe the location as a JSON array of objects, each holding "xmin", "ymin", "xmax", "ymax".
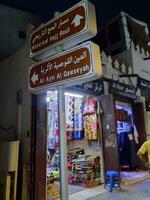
[{"xmin": 115, "ymin": 101, "xmax": 148, "ymax": 184}]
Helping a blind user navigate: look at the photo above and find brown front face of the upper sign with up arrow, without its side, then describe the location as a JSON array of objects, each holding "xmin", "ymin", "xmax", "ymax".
[{"xmin": 31, "ymin": 6, "xmax": 85, "ymax": 53}]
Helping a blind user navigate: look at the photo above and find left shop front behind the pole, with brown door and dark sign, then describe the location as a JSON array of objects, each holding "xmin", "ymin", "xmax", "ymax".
[{"xmin": 29, "ymin": 79, "xmax": 108, "ymax": 200}]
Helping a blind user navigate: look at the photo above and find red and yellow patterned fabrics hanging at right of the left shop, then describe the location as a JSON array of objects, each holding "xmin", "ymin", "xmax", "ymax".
[{"xmin": 83, "ymin": 99, "xmax": 98, "ymax": 140}]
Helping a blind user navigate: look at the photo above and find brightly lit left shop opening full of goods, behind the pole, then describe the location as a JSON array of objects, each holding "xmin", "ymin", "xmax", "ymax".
[{"xmin": 46, "ymin": 90, "xmax": 103, "ymax": 199}]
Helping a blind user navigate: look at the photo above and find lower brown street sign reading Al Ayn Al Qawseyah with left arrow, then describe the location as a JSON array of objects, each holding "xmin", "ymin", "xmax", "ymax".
[{"xmin": 28, "ymin": 42, "xmax": 102, "ymax": 92}]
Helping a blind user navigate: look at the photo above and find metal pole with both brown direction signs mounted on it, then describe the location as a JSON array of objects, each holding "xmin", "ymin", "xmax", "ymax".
[{"xmin": 28, "ymin": 0, "xmax": 102, "ymax": 200}]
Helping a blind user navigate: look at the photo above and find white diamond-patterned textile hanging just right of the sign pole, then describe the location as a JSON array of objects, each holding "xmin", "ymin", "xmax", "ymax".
[{"xmin": 65, "ymin": 95, "xmax": 74, "ymax": 140}]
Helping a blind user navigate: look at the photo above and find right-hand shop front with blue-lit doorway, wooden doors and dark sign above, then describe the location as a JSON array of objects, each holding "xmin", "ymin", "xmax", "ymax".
[{"xmin": 102, "ymin": 80, "xmax": 147, "ymax": 184}]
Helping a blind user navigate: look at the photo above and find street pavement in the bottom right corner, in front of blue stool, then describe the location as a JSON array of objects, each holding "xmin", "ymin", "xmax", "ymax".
[{"xmin": 89, "ymin": 179, "xmax": 150, "ymax": 200}]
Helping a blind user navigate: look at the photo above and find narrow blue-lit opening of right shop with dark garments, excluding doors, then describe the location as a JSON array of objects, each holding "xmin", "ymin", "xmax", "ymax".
[{"xmin": 115, "ymin": 100, "xmax": 139, "ymax": 171}]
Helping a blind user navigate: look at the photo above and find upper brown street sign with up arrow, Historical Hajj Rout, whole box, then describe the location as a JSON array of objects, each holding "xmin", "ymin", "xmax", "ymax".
[{"xmin": 30, "ymin": 0, "xmax": 97, "ymax": 60}]
